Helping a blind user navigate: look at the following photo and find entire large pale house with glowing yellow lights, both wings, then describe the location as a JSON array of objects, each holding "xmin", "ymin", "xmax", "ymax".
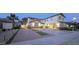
[{"xmin": 23, "ymin": 13, "xmax": 66, "ymax": 29}]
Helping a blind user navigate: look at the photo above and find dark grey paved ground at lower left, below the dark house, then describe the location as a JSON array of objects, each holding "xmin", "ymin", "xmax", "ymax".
[{"xmin": 0, "ymin": 29, "xmax": 17, "ymax": 44}]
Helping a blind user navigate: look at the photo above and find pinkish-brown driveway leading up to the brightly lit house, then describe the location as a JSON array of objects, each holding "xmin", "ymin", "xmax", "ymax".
[{"xmin": 12, "ymin": 29, "xmax": 41, "ymax": 44}]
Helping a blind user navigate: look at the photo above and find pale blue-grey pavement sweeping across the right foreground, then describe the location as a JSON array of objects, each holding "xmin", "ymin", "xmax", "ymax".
[{"xmin": 12, "ymin": 30, "xmax": 79, "ymax": 45}]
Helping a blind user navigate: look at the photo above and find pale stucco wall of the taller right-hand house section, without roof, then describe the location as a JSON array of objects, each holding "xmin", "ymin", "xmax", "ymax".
[{"xmin": 45, "ymin": 15, "xmax": 65, "ymax": 29}]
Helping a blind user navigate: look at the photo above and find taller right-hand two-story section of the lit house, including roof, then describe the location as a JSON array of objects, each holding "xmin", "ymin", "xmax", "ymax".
[{"xmin": 45, "ymin": 13, "xmax": 65, "ymax": 29}]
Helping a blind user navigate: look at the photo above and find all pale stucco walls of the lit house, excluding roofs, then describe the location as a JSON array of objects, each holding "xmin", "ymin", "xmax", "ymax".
[{"xmin": 27, "ymin": 15, "xmax": 66, "ymax": 28}]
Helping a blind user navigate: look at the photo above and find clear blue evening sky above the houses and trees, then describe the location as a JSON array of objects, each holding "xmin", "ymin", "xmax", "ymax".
[{"xmin": 0, "ymin": 13, "xmax": 79, "ymax": 21}]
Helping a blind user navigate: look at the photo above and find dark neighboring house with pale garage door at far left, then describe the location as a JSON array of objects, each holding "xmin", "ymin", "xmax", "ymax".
[{"xmin": 0, "ymin": 18, "xmax": 21, "ymax": 29}]
